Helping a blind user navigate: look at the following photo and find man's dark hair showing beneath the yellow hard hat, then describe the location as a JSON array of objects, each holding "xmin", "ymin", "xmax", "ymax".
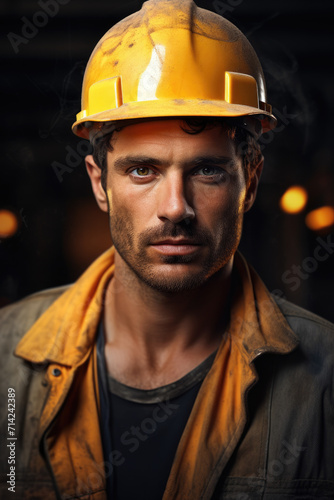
[{"xmin": 93, "ymin": 117, "xmax": 262, "ymax": 189}]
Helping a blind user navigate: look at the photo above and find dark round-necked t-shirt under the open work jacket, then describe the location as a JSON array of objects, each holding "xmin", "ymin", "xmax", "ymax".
[{"xmin": 98, "ymin": 325, "xmax": 216, "ymax": 500}]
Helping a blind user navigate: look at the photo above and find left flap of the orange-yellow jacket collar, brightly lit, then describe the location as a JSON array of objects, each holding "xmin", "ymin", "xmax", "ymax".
[{"xmin": 15, "ymin": 248, "xmax": 114, "ymax": 366}]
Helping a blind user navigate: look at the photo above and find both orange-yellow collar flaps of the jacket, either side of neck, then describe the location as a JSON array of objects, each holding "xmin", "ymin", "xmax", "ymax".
[{"xmin": 15, "ymin": 248, "xmax": 298, "ymax": 366}]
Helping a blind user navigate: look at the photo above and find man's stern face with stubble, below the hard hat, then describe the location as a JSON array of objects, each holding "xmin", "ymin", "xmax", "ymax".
[{"xmin": 88, "ymin": 120, "xmax": 256, "ymax": 292}]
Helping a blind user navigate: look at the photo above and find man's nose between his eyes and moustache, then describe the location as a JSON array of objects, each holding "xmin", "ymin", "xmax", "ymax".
[{"xmin": 157, "ymin": 172, "xmax": 195, "ymax": 224}]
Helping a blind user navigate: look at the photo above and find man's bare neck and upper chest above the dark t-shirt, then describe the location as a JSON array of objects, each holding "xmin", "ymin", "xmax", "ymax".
[{"xmin": 104, "ymin": 256, "xmax": 232, "ymax": 389}]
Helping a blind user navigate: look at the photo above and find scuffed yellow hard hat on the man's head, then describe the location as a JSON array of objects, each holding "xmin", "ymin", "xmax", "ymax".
[{"xmin": 72, "ymin": 0, "xmax": 276, "ymax": 139}]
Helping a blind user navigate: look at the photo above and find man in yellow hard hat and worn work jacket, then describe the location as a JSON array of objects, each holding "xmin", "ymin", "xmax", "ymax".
[{"xmin": 1, "ymin": 0, "xmax": 334, "ymax": 500}]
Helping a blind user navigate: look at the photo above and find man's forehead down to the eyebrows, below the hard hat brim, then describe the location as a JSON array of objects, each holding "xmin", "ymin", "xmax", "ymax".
[{"xmin": 104, "ymin": 120, "xmax": 240, "ymax": 171}]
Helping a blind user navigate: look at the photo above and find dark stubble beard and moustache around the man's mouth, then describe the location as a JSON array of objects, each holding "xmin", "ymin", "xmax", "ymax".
[{"xmin": 109, "ymin": 210, "xmax": 242, "ymax": 294}]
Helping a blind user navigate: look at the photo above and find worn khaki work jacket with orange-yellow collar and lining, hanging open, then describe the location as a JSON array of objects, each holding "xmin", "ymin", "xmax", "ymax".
[{"xmin": 0, "ymin": 249, "xmax": 334, "ymax": 500}]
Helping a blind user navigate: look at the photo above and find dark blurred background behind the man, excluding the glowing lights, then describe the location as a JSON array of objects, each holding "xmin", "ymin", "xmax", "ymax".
[{"xmin": 0, "ymin": 0, "xmax": 334, "ymax": 321}]
